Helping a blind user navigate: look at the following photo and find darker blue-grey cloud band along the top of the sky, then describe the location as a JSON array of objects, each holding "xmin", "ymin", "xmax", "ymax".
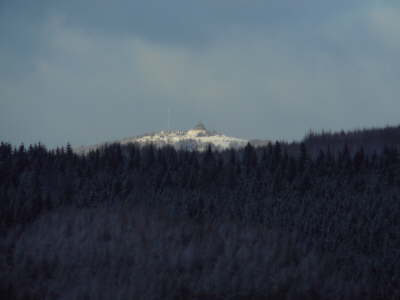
[{"xmin": 0, "ymin": 0, "xmax": 370, "ymax": 46}]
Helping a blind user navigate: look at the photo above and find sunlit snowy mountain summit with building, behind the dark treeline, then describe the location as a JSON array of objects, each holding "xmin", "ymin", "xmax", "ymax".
[{"xmin": 75, "ymin": 123, "xmax": 249, "ymax": 154}]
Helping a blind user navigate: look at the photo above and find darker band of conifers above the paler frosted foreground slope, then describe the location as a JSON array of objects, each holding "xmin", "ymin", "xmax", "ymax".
[{"xmin": 0, "ymin": 127, "xmax": 400, "ymax": 299}]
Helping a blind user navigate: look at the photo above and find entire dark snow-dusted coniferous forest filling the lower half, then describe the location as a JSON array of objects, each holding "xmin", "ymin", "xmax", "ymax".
[{"xmin": 0, "ymin": 127, "xmax": 400, "ymax": 300}]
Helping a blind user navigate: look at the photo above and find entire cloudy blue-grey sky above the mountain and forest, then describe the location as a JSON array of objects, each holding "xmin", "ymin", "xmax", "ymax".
[{"xmin": 0, "ymin": 0, "xmax": 400, "ymax": 147}]
